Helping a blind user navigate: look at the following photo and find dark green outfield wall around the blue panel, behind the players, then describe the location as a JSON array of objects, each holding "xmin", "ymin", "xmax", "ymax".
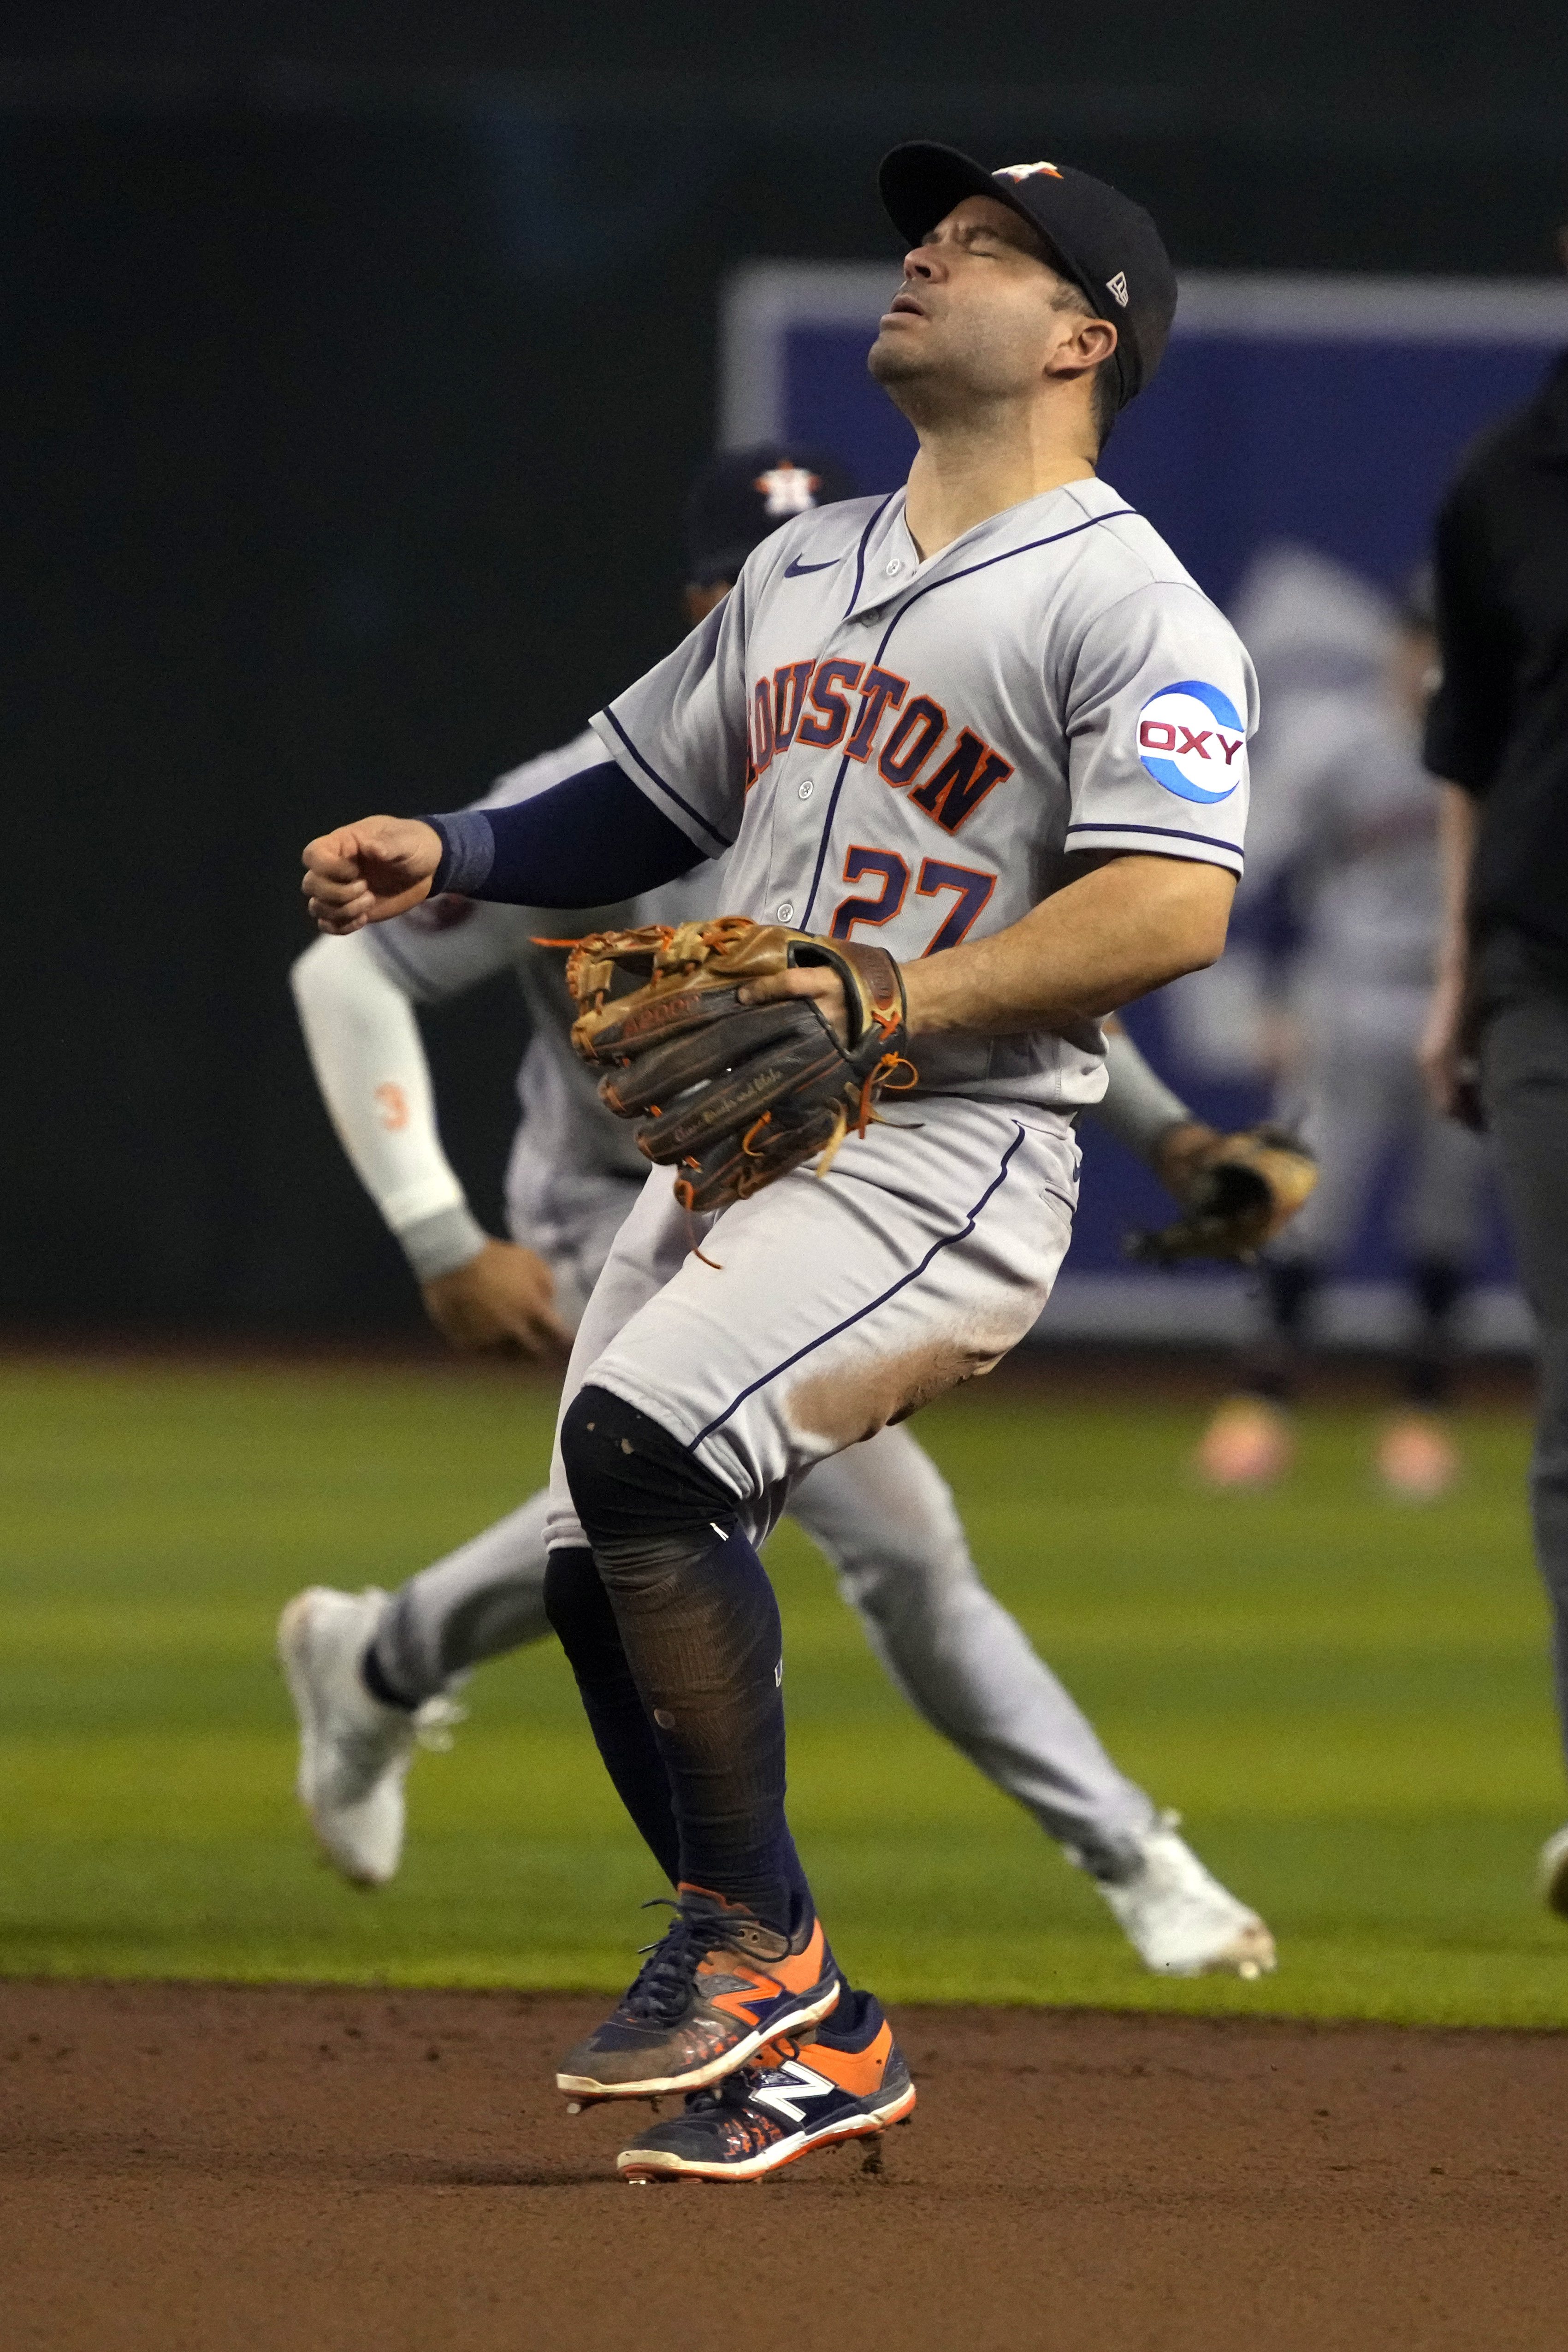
[{"xmin": 0, "ymin": 27, "xmax": 1568, "ymax": 1329}]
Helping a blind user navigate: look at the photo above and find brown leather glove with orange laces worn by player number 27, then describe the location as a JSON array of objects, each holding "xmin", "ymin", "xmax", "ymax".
[{"xmin": 557, "ymin": 915, "xmax": 914, "ymax": 1209}]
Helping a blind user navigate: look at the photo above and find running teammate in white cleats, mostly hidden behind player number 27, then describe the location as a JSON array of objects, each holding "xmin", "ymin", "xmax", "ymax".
[{"xmin": 282, "ymin": 447, "xmax": 1274, "ymax": 1976}]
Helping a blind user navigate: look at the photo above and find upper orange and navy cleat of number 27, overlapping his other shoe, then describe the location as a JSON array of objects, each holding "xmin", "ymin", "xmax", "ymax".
[{"xmin": 555, "ymin": 1884, "xmax": 841, "ymax": 2105}]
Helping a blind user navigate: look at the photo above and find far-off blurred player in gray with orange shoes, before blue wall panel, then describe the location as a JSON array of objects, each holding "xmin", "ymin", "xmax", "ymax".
[{"xmin": 1199, "ymin": 551, "xmax": 1483, "ymax": 1500}]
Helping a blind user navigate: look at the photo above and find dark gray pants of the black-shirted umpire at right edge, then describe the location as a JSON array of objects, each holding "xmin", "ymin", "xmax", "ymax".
[{"xmin": 1476, "ymin": 936, "xmax": 1568, "ymax": 1743}]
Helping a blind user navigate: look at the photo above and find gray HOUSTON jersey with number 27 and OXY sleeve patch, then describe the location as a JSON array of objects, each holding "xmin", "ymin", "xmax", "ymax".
[{"xmin": 592, "ymin": 480, "xmax": 1255, "ymax": 1110}]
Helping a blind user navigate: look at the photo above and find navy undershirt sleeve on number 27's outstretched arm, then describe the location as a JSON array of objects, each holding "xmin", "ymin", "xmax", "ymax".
[{"xmin": 426, "ymin": 760, "xmax": 703, "ymax": 906}]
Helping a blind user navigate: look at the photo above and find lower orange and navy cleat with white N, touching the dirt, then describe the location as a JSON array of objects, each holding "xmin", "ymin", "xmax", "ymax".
[{"xmin": 616, "ymin": 1992, "xmax": 914, "ymax": 2185}]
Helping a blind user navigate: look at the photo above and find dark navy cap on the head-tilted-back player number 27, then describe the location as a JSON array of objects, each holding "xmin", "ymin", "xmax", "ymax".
[{"xmin": 879, "ymin": 139, "xmax": 1175, "ymax": 407}]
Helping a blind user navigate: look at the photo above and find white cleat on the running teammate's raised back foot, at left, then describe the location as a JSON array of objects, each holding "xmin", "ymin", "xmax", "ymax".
[{"xmin": 278, "ymin": 1585, "xmax": 463, "ymax": 1886}]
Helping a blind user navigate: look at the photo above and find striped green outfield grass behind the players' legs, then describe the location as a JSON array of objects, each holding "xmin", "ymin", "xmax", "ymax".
[{"xmin": 0, "ymin": 1364, "xmax": 1568, "ymax": 2025}]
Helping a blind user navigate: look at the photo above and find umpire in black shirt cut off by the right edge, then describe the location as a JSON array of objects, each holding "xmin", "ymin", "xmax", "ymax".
[{"xmin": 1422, "ymin": 275, "xmax": 1568, "ymax": 1917}]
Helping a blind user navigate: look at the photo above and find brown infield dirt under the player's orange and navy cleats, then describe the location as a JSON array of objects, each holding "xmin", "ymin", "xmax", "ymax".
[{"xmin": 0, "ymin": 1983, "xmax": 1568, "ymax": 2352}]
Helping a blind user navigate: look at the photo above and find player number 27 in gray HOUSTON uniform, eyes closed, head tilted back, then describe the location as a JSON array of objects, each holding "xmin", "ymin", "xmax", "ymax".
[{"xmin": 303, "ymin": 156, "xmax": 1255, "ymax": 2180}]
